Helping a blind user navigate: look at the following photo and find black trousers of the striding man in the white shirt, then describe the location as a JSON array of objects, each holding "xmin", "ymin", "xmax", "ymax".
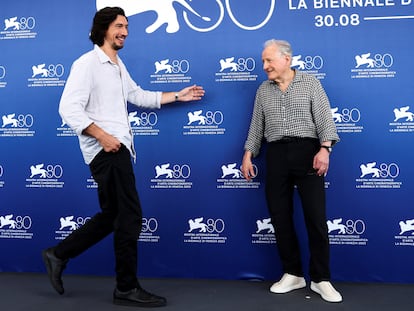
[{"xmin": 55, "ymin": 146, "xmax": 142, "ymax": 291}]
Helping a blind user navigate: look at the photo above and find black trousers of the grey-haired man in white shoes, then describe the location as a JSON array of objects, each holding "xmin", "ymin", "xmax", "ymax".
[{"xmin": 266, "ymin": 138, "xmax": 330, "ymax": 282}]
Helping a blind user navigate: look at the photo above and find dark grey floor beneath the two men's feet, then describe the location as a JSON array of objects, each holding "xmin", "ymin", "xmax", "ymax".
[{"xmin": 0, "ymin": 273, "xmax": 414, "ymax": 311}]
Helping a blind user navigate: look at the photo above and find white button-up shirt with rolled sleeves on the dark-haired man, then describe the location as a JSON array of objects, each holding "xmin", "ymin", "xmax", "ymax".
[{"xmin": 59, "ymin": 45, "xmax": 162, "ymax": 164}]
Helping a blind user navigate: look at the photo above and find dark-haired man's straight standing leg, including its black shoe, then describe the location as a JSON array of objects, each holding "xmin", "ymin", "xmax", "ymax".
[{"xmin": 108, "ymin": 146, "xmax": 167, "ymax": 307}]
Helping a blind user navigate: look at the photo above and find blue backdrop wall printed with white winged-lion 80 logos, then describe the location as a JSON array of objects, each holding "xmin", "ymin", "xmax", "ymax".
[{"xmin": 0, "ymin": 0, "xmax": 414, "ymax": 283}]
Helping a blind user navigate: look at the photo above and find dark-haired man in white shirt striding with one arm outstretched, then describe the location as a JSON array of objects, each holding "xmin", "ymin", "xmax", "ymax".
[{"xmin": 42, "ymin": 7, "xmax": 204, "ymax": 307}]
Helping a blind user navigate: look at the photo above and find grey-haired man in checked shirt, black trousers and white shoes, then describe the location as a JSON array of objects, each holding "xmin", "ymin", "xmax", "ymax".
[{"xmin": 242, "ymin": 39, "xmax": 342, "ymax": 302}]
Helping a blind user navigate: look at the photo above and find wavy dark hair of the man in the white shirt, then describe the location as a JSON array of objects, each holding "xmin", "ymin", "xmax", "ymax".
[{"xmin": 89, "ymin": 7, "xmax": 128, "ymax": 46}]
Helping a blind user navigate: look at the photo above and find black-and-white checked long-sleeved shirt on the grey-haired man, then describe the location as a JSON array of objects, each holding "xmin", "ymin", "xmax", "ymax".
[{"xmin": 244, "ymin": 70, "xmax": 339, "ymax": 157}]
